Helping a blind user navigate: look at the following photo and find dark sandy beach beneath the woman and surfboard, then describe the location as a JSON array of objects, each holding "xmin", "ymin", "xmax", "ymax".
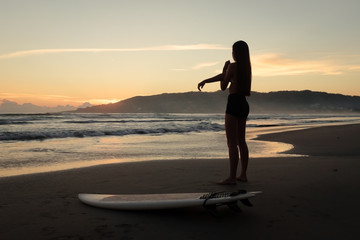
[{"xmin": 0, "ymin": 125, "xmax": 360, "ymax": 240}]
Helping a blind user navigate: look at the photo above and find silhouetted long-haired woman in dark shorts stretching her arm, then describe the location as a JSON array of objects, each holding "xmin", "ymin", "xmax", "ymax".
[{"xmin": 198, "ymin": 41, "xmax": 251, "ymax": 185}]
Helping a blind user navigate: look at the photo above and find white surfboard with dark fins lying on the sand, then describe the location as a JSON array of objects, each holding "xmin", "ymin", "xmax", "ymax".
[{"xmin": 79, "ymin": 190, "xmax": 261, "ymax": 210}]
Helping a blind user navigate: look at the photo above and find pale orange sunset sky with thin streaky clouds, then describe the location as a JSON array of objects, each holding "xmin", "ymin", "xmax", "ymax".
[{"xmin": 0, "ymin": 0, "xmax": 360, "ymax": 106}]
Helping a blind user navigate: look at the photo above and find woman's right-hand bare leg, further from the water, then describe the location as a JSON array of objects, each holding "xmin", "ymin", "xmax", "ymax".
[{"xmin": 237, "ymin": 118, "xmax": 249, "ymax": 182}]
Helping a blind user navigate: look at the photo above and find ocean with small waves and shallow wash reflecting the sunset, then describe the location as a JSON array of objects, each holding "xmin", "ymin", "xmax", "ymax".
[{"xmin": 0, "ymin": 113, "xmax": 360, "ymax": 177}]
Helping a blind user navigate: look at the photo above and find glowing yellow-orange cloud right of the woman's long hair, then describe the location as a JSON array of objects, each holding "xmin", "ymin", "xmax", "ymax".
[{"xmin": 251, "ymin": 53, "xmax": 360, "ymax": 77}]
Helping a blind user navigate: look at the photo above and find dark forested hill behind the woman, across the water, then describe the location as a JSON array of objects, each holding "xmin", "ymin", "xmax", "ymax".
[{"xmin": 76, "ymin": 90, "xmax": 360, "ymax": 113}]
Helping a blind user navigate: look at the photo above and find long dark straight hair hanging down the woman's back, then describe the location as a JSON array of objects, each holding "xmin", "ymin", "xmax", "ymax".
[{"xmin": 233, "ymin": 41, "xmax": 252, "ymax": 96}]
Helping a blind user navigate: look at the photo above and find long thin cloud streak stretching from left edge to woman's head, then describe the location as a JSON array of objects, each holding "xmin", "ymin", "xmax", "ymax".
[{"xmin": 0, "ymin": 43, "xmax": 229, "ymax": 59}]
